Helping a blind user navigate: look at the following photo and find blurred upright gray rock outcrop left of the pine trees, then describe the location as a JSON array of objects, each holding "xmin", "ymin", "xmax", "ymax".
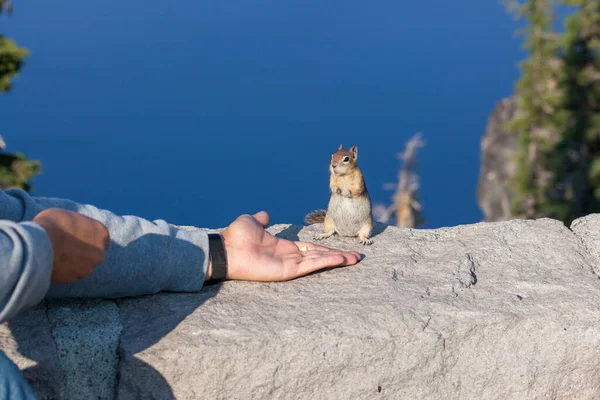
[{"xmin": 477, "ymin": 96, "xmax": 518, "ymax": 221}]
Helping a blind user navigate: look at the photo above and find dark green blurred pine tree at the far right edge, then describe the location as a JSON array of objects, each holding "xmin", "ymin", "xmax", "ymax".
[{"xmin": 551, "ymin": 0, "xmax": 600, "ymax": 224}]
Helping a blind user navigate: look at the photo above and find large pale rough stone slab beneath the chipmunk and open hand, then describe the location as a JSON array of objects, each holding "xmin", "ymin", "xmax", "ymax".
[{"xmin": 3, "ymin": 216, "xmax": 600, "ymax": 399}]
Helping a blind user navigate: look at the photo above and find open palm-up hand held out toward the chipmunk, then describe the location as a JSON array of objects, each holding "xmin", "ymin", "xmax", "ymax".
[{"xmin": 206, "ymin": 211, "xmax": 360, "ymax": 282}]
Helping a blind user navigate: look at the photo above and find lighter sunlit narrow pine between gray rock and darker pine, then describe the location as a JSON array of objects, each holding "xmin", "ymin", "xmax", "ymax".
[{"xmin": 507, "ymin": 0, "xmax": 561, "ymax": 218}]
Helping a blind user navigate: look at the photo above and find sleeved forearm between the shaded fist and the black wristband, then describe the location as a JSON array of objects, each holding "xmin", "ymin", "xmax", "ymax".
[{"xmin": 48, "ymin": 216, "xmax": 208, "ymax": 298}]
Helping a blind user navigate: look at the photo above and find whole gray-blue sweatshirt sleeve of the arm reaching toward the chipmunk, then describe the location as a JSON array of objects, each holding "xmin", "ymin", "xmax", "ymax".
[{"xmin": 0, "ymin": 189, "xmax": 208, "ymax": 304}]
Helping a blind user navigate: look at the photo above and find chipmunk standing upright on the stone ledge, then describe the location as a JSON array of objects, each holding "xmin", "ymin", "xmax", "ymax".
[{"xmin": 304, "ymin": 144, "xmax": 373, "ymax": 245}]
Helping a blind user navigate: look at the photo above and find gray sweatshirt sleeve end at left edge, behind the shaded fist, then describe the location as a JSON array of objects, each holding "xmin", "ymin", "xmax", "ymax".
[{"xmin": 0, "ymin": 221, "xmax": 53, "ymax": 323}]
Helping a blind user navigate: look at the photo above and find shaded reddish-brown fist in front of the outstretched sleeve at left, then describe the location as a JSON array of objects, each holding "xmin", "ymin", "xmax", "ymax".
[{"xmin": 33, "ymin": 208, "xmax": 110, "ymax": 283}]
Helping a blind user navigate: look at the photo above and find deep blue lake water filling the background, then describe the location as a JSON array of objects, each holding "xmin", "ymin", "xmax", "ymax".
[{"xmin": 0, "ymin": 0, "xmax": 524, "ymax": 228}]
